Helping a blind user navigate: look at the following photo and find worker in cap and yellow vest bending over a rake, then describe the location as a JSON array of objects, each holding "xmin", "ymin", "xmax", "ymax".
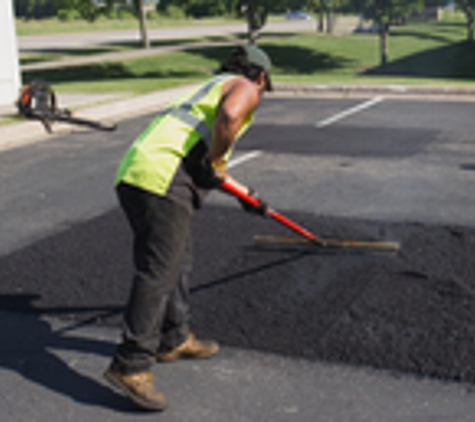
[{"xmin": 104, "ymin": 45, "xmax": 272, "ymax": 411}]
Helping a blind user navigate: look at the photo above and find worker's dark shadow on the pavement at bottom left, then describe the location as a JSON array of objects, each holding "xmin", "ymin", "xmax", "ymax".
[{"xmin": 0, "ymin": 295, "xmax": 137, "ymax": 411}]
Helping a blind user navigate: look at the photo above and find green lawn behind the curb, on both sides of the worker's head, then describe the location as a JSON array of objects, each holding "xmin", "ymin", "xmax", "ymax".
[{"xmin": 23, "ymin": 22, "xmax": 475, "ymax": 94}]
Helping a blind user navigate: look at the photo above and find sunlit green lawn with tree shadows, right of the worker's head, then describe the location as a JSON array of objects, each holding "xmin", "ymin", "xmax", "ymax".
[{"xmin": 262, "ymin": 23, "xmax": 475, "ymax": 84}]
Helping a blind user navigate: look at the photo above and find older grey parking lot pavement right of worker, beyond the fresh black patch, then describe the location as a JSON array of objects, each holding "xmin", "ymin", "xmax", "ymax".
[{"xmin": 228, "ymin": 97, "xmax": 475, "ymax": 225}]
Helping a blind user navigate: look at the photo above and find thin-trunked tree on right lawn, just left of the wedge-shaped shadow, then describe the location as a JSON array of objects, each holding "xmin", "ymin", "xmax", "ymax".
[{"xmin": 354, "ymin": 0, "xmax": 424, "ymax": 66}]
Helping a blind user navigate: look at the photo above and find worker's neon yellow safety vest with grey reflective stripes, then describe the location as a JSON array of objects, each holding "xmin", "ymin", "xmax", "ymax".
[{"xmin": 115, "ymin": 74, "xmax": 254, "ymax": 196}]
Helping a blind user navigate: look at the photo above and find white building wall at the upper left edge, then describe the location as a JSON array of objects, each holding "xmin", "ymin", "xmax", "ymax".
[{"xmin": 0, "ymin": 0, "xmax": 21, "ymax": 105}]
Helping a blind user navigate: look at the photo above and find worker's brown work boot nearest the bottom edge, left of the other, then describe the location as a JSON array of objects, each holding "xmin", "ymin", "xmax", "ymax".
[{"xmin": 104, "ymin": 368, "xmax": 168, "ymax": 411}]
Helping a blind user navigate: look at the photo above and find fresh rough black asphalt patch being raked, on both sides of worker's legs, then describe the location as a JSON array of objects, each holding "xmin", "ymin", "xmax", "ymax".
[{"xmin": 0, "ymin": 203, "xmax": 475, "ymax": 383}]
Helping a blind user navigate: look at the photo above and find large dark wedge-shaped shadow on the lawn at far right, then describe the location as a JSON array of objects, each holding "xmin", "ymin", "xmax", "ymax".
[{"xmin": 362, "ymin": 41, "xmax": 475, "ymax": 81}]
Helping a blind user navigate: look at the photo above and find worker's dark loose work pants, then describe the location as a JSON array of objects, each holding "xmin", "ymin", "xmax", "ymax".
[{"xmin": 112, "ymin": 183, "xmax": 192, "ymax": 373}]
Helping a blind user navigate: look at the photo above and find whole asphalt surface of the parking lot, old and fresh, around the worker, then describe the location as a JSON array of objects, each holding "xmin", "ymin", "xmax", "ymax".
[{"xmin": 0, "ymin": 98, "xmax": 475, "ymax": 422}]
